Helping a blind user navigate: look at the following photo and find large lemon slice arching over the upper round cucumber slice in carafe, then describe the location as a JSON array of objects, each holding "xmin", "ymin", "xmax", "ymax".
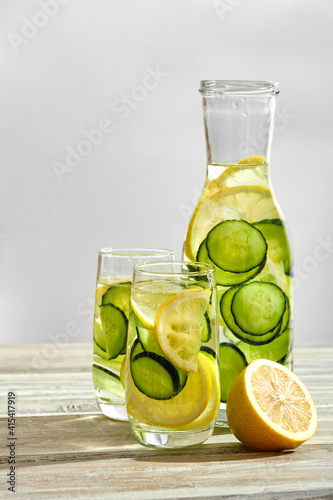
[{"xmin": 185, "ymin": 186, "xmax": 280, "ymax": 258}]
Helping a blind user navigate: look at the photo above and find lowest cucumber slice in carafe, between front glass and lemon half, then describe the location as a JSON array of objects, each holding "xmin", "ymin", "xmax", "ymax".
[{"xmin": 219, "ymin": 342, "xmax": 247, "ymax": 403}]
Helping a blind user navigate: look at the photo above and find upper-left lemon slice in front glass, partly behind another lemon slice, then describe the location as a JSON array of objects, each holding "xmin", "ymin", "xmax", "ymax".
[{"xmin": 131, "ymin": 280, "xmax": 183, "ymax": 330}]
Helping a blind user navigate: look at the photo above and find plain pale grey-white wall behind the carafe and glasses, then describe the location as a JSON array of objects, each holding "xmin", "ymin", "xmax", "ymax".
[{"xmin": 0, "ymin": 0, "xmax": 333, "ymax": 344}]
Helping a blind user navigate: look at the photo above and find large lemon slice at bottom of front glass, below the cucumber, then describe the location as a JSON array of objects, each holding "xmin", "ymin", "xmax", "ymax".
[{"xmin": 126, "ymin": 354, "xmax": 212, "ymax": 429}]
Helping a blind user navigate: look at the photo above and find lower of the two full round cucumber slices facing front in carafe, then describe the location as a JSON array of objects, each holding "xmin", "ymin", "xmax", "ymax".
[{"xmin": 231, "ymin": 281, "xmax": 286, "ymax": 335}]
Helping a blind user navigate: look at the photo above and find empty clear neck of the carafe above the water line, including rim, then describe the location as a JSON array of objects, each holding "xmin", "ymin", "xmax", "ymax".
[{"xmin": 200, "ymin": 80, "xmax": 279, "ymax": 165}]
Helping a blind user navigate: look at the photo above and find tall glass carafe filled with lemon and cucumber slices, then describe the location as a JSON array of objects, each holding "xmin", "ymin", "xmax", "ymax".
[{"xmin": 183, "ymin": 80, "xmax": 293, "ymax": 426}]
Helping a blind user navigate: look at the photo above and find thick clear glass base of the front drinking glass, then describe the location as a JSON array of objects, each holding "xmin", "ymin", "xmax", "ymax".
[{"xmin": 129, "ymin": 417, "xmax": 214, "ymax": 449}]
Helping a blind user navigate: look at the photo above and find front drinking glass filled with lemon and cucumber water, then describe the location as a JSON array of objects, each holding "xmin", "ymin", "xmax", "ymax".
[{"xmin": 125, "ymin": 261, "xmax": 220, "ymax": 448}]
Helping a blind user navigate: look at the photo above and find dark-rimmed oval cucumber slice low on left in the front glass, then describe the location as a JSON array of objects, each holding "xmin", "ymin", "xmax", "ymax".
[{"xmin": 130, "ymin": 351, "xmax": 181, "ymax": 399}]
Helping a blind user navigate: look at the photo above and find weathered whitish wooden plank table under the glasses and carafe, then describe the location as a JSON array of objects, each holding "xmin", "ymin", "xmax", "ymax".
[{"xmin": 0, "ymin": 343, "xmax": 333, "ymax": 500}]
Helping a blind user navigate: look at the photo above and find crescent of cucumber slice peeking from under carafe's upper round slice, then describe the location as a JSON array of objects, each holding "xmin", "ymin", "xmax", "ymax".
[{"xmin": 196, "ymin": 239, "xmax": 266, "ymax": 286}]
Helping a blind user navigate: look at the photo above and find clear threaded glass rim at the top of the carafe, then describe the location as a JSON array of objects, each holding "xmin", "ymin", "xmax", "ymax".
[{"xmin": 199, "ymin": 80, "xmax": 279, "ymax": 97}]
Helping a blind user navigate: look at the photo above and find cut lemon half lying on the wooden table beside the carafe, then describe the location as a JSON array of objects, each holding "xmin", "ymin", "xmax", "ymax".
[{"xmin": 226, "ymin": 359, "xmax": 317, "ymax": 451}]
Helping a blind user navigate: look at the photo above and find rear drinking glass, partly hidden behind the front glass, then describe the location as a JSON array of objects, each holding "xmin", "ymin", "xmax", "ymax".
[{"xmin": 92, "ymin": 248, "xmax": 173, "ymax": 420}]
